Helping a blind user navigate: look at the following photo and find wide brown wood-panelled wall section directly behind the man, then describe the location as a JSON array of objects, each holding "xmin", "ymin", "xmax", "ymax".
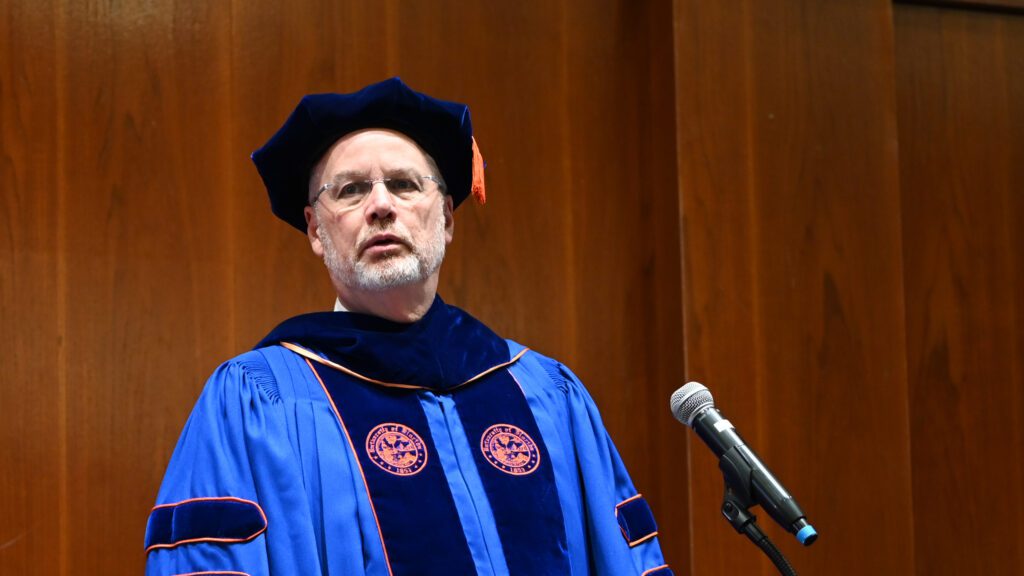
[{"xmin": 6, "ymin": 0, "xmax": 688, "ymax": 574}]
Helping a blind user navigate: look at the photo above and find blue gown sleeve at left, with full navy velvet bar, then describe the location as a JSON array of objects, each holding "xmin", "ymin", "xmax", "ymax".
[{"xmin": 145, "ymin": 353, "xmax": 321, "ymax": 576}]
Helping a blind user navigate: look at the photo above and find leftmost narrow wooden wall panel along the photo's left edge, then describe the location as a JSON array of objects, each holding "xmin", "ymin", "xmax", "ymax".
[{"xmin": 0, "ymin": 2, "xmax": 68, "ymax": 574}]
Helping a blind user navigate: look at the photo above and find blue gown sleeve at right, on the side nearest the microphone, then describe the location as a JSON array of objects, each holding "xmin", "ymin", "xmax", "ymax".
[{"xmin": 556, "ymin": 363, "xmax": 673, "ymax": 576}]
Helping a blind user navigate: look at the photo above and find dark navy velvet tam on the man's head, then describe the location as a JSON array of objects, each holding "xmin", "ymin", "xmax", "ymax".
[{"xmin": 252, "ymin": 78, "xmax": 473, "ymax": 234}]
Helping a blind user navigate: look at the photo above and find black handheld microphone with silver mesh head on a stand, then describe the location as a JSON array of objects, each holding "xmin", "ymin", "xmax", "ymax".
[{"xmin": 670, "ymin": 382, "xmax": 818, "ymax": 546}]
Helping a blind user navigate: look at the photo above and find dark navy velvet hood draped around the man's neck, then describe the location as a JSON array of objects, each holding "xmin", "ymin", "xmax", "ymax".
[{"xmin": 256, "ymin": 296, "xmax": 510, "ymax": 390}]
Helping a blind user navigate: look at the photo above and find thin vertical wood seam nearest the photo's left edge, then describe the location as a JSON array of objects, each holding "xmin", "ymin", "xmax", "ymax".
[{"xmin": 51, "ymin": 2, "xmax": 71, "ymax": 576}]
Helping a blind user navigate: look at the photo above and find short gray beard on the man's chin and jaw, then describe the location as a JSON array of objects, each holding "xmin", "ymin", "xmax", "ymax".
[{"xmin": 316, "ymin": 211, "xmax": 445, "ymax": 292}]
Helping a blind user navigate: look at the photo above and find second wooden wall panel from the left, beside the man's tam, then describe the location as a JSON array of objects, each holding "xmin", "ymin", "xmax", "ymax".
[{"xmin": 59, "ymin": 2, "xmax": 236, "ymax": 574}]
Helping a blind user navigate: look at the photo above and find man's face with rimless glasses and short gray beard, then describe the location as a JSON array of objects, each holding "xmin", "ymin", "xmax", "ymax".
[{"xmin": 306, "ymin": 129, "xmax": 454, "ymax": 292}]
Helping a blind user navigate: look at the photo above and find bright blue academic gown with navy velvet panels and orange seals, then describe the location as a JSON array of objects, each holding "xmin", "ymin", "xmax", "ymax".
[{"xmin": 145, "ymin": 297, "xmax": 672, "ymax": 576}]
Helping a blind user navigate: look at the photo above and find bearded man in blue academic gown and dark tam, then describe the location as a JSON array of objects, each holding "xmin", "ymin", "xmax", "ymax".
[{"xmin": 145, "ymin": 78, "xmax": 672, "ymax": 576}]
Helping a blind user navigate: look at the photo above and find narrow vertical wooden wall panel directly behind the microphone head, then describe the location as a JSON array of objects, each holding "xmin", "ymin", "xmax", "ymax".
[{"xmin": 674, "ymin": 2, "xmax": 761, "ymax": 575}]
